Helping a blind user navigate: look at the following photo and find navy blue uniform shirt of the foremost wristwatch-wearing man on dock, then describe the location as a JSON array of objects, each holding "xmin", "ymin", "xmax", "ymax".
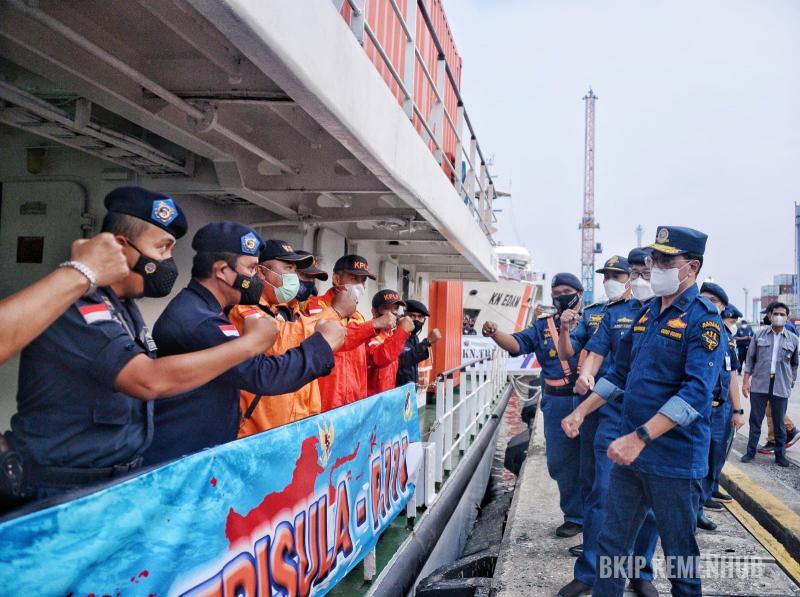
[{"xmin": 595, "ymin": 285, "xmax": 727, "ymax": 479}]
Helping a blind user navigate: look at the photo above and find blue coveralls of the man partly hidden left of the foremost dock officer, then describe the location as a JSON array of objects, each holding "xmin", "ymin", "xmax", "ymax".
[{"xmin": 574, "ymin": 299, "xmax": 658, "ymax": 586}]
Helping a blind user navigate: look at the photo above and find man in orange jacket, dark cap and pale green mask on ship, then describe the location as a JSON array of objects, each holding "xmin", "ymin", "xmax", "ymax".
[{"xmin": 228, "ymin": 240, "xmax": 346, "ymax": 437}]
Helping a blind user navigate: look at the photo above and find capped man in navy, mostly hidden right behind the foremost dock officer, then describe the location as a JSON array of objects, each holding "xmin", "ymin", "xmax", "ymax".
[{"xmin": 697, "ymin": 282, "xmax": 744, "ymax": 531}]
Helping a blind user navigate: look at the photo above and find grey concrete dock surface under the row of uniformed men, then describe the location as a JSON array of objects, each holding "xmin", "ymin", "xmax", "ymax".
[{"xmin": 493, "ymin": 413, "xmax": 800, "ymax": 597}]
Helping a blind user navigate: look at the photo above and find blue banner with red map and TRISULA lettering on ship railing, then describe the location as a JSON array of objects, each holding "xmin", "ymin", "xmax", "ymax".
[{"xmin": 0, "ymin": 384, "xmax": 421, "ymax": 597}]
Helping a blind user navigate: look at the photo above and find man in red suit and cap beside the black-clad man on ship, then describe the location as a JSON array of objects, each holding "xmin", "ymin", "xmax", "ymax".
[{"xmin": 367, "ymin": 289, "xmax": 414, "ymax": 396}]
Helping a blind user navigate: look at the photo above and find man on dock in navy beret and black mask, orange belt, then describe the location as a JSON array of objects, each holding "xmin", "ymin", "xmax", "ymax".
[{"xmin": 483, "ymin": 273, "xmax": 583, "ymax": 537}]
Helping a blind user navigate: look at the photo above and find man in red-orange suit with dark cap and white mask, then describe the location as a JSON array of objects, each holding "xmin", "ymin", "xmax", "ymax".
[{"xmin": 306, "ymin": 255, "xmax": 397, "ymax": 411}]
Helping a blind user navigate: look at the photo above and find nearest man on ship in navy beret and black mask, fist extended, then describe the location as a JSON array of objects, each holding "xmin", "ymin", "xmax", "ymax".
[{"xmin": 11, "ymin": 187, "xmax": 274, "ymax": 498}]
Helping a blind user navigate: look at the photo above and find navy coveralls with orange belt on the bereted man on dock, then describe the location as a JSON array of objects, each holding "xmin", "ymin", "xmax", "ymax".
[{"xmin": 512, "ymin": 318, "xmax": 583, "ymax": 524}]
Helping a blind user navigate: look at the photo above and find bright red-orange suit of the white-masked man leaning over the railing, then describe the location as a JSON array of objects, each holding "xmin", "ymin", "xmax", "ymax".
[{"xmin": 306, "ymin": 288, "xmax": 375, "ymax": 412}]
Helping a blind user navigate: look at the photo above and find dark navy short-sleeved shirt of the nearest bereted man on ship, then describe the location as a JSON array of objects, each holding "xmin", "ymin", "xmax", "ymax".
[{"xmin": 11, "ymin": 288, "xmax": 156, "ymax": 498}]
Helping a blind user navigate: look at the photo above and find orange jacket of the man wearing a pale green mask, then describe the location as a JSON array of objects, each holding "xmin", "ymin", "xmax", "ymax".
[{"xmin": 228, "ymin": 298, "xmax": 338, "ymax": 437}]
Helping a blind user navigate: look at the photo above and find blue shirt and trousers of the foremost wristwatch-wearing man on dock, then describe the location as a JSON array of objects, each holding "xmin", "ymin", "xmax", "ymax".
[{"xmin": 593, "ymin": 285, "xmax": 726, "ymax": 597}]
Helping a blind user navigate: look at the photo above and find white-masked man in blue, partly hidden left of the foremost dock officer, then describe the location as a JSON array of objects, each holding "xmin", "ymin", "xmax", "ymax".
[{"xmin": 558, "ymin": 248, "xmax": 658, "ymax": 597}]
